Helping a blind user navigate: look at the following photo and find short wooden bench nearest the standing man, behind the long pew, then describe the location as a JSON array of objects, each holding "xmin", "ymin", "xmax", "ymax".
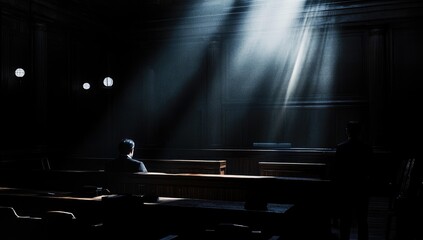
[{"xmin": 259, "ymin": 162, "xmax": 329, "ymax": 179}]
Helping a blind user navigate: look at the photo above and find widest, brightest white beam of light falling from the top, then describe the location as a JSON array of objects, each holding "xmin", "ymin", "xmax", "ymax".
[{"xmin": 220, "ymin": 0, "xmax": 340, "ymax": 146}]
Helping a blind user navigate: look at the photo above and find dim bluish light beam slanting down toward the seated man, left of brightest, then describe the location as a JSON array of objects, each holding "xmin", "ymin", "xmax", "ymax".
[{"xmin": 105, "ymin": 0, "xmax": 233, "ymax": 149}]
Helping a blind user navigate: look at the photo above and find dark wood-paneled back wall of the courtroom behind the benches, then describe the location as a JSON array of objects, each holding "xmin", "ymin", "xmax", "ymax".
[{"xmin": 0, "ymin": 1, "xmax": 423, "ymax": 159}]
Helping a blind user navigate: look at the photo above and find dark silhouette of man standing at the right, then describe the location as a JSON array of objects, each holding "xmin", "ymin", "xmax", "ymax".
[{"xmin": 333, "ymin": 121, "xmax": 372, "ymax": 240}]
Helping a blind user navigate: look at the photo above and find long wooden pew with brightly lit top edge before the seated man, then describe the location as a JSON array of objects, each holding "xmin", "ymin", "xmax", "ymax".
[{"xmin": 0, "ymin": 170, "xmax": 331, "ymax": 203}]
